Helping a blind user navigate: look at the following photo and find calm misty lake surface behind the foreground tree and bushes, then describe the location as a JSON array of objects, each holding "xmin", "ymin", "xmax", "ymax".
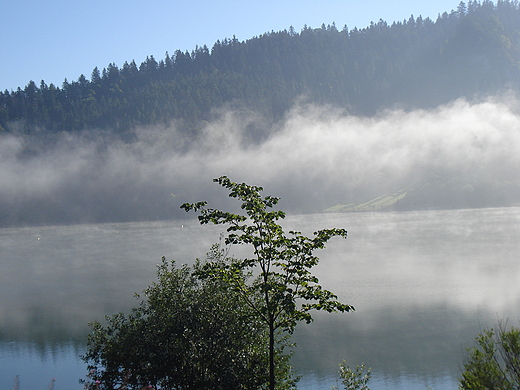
[{"xmin": 0, "ymin": 208, "xmax": 520, "ymax": 390}]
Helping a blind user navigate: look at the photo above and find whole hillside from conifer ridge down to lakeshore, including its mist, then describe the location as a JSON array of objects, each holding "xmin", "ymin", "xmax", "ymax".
[{"xmin": 0, "ymin": 1, "xmax": 520, "ymax": 226}]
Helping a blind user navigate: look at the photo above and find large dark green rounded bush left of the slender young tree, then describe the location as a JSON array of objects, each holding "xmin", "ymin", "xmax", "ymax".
[{"xmin": 82, "ymin": 248, "xmax": 292, "ymax": 390}]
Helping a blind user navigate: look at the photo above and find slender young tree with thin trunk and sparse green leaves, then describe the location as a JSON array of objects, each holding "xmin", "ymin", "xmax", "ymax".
[{"xmin": 181, "ymin": 176, "xmax": 354, "ymax": 390}]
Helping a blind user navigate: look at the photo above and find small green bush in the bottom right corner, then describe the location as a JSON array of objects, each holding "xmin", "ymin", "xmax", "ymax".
[{"xmin": 460, "ymin": 324, "xmax": 520, "ymax": 390}]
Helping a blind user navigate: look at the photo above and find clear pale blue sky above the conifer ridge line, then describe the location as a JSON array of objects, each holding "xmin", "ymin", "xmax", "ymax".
[{"xmin": 0, "ymin": 0, "xmax": 458, "ymax": 91}]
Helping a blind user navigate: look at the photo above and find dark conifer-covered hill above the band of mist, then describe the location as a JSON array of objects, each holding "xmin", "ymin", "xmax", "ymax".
[{"xmin": 0, "ymin": 0, "xmax": 520, "ymax": 136}]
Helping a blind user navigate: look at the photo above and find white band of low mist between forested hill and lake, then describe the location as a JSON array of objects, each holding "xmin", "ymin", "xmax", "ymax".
[{"xmin": 0, "ymin": 95, "xmax": 520, "ymax": 226}]
